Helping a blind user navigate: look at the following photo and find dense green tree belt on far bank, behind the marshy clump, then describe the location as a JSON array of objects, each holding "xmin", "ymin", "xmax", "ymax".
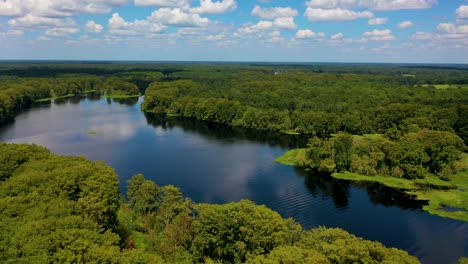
[{"xmin": 142, "ymin": 70, "xmax": 468, "ymax": 142}]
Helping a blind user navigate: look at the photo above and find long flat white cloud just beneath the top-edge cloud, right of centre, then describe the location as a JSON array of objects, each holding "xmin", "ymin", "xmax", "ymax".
[{"xmin": 304, "ymin": 7, "xmax": 374, "ymax": 21}]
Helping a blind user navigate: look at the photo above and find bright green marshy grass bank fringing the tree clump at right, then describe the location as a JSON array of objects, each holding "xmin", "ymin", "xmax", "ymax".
[{"xmin": 275, "ymin": 149, "xmax": 468, "ymax": 222}]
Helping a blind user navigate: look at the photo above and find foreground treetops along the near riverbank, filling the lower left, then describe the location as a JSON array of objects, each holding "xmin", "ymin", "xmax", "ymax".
[{"xmin": 0, "ymin": 143, "xmax": 419, "ymax": 263}]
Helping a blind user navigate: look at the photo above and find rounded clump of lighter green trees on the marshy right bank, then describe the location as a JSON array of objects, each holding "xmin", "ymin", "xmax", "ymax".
[{"xmin": 298, "ymin": 129, "xmax": 466, "ymax": 180}]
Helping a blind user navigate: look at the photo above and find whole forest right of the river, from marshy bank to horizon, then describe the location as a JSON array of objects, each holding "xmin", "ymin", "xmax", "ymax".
[{"xmin": 142, "ymin": 63, "xmax": 468, "ymax": 221}]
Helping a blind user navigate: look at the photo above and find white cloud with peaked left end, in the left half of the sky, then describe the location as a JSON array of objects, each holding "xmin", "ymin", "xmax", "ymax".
[{"xmin": 109, "ymin": 13, "xmax": 165, "ymax": 35}]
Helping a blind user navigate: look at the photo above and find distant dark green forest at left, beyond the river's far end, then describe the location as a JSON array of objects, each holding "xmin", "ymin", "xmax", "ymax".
[{"xmin": 0, "ymin": 64, "xmax": 163, "ymax": 124}]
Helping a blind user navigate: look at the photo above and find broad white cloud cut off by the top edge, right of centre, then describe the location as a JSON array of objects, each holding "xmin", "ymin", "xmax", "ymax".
[{"xmin": 306, "ymin": 0, "xmax": 437, "ymax": 11}]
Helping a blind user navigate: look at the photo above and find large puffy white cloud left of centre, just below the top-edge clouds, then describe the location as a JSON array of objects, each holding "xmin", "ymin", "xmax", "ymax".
[{"xmin": 148, "ymin": 8, "xmax": 210, "ymax": 27}]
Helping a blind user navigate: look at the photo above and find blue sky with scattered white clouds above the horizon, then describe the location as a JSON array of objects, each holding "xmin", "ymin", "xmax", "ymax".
[{"xmin": 0, "ymin": 0, "xmax": 468, "ymax": 63}]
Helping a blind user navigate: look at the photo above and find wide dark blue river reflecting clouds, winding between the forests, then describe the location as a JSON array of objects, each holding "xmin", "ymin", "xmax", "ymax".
[{"xmin": 0, "ymin": 95, "xmax": 468, "ymax": 263}]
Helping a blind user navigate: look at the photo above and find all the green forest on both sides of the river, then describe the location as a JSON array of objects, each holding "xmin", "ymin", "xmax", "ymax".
[{"xmin": 0, "ymin": 62, "xmax": 468, "ymax": 263}]
